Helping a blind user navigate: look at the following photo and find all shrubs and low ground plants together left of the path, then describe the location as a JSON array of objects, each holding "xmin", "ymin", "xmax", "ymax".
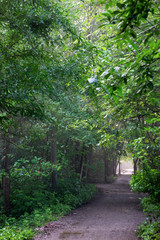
[{"xmin": 0, "ymin": 157, "xmax": 96, "ymax": 240}]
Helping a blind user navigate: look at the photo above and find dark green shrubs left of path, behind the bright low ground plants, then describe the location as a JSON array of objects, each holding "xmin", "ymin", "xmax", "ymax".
[{"xmin": 10, "ymin": 157, "xmax": 95, "ymax": 218}]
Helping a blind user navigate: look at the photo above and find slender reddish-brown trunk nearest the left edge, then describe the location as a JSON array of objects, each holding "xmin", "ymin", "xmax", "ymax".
[{"xmin": 3, "ymin": 138, "xmax": 10, "ymax": 216}]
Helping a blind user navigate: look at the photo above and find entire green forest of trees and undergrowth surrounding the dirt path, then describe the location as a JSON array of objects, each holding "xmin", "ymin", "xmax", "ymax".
[{"xmin": 0, "ymin": 0, "xmax": 160, "ymax": 240}]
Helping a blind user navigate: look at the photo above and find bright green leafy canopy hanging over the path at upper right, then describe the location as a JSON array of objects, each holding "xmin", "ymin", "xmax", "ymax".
[{"xmin": 95, "ymin": 0, "xmax": 160, "ymax": 163}]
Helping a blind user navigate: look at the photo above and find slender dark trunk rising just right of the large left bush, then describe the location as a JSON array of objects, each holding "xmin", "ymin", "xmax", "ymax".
[{"xmin": 51, "ymin": 128, "xmax": 57, "ymax": 190}]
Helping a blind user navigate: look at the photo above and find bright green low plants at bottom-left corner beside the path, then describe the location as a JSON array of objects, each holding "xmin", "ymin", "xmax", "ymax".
[{"xmin": 0, "ymin": 203, "xmax": 71, "ymax": 240}]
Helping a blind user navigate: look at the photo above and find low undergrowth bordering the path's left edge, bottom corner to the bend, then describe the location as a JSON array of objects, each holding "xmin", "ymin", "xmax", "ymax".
[{"xmin": 0, "ymin": 180, "xmax": 96, "ymax": 240}]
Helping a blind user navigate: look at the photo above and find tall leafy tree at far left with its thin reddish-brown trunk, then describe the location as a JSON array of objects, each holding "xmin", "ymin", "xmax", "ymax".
[{"xmin": 0, "ymin": 0, "xmax": 87, "ymax": 215}]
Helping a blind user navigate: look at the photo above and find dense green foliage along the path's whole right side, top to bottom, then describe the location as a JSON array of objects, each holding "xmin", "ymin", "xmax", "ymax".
[{"xmin": 95, "ymin": 0, "xmax": 160, "ymax": 239}]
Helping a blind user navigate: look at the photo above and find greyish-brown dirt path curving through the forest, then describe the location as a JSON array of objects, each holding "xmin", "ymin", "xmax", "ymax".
[{"xmin": 36, "ymin": 175, "xmax": 144, "ymax": 240}]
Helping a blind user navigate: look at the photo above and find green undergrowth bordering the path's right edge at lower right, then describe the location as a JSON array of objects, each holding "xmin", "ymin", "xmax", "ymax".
[{"xmin": 130, "ymin": 170, "xmax": 160, "ymax": 240}]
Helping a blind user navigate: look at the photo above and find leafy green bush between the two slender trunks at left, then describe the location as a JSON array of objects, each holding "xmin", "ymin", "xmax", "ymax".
[{"xmin": 10, "ymin": 157, "xmax": 58, "ymax": 217}]
